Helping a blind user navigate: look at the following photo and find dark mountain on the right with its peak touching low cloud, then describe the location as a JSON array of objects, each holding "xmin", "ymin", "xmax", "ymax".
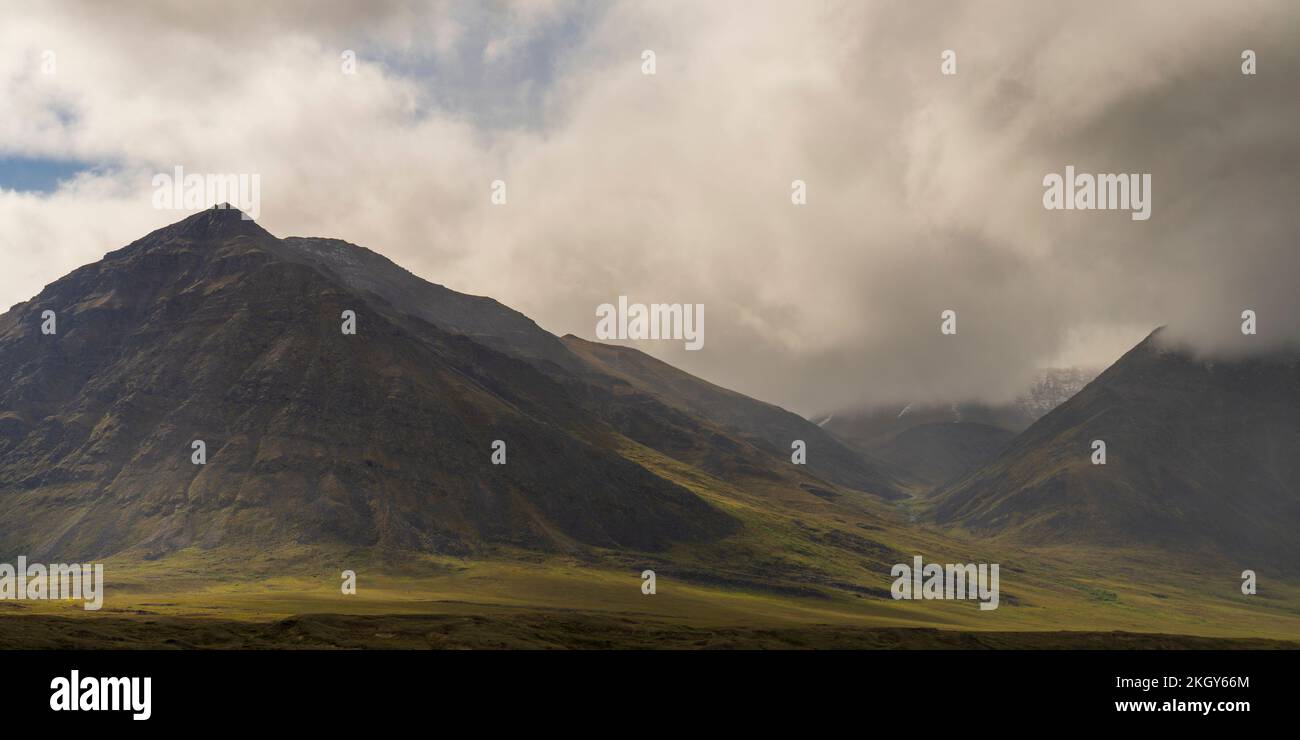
[{"xmin": 931, "ymin": 330, "xmax": 1300, "ymax": 562}]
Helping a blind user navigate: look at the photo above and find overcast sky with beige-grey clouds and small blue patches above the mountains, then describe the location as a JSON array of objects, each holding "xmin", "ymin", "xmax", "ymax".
[{"xmin": 0, "ymin": 0, "xmax": 1300, "ymax": 414}]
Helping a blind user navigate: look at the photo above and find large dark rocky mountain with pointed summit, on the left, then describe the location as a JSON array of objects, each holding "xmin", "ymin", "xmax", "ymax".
[{"xmin": 0, "ymin": 208, "xmax": 738, "ymax": 562}]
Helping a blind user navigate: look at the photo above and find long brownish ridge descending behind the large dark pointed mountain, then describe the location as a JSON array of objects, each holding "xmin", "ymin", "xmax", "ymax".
[{"xmin": 262, "ymin": 231, "xmax": 900, "ymax": 498}]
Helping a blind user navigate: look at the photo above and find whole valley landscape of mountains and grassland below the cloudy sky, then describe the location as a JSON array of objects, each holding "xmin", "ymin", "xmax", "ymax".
[{"xmin": 0, "ymin": 209, "xmax": 1300, "ymax": 648}]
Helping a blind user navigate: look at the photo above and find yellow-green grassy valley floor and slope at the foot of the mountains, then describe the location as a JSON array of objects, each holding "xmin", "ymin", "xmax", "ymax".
[{"xmin": 0, "ymin": 392, "xmax": 1300, "ymax": 648}]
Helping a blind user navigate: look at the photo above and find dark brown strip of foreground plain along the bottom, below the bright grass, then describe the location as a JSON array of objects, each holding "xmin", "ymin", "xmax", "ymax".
[{"xmin": 0, "ymin": 613, "xmax": 1300, "ymax": 650}]
